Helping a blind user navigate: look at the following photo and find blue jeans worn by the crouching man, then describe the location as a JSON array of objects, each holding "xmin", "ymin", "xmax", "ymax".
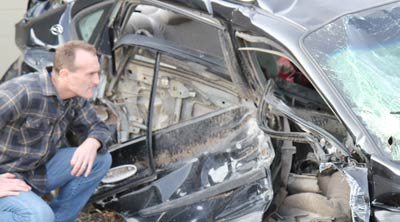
[{"xmin": 0, "ymin": 148, "xmax": 111, "ymax": 222}]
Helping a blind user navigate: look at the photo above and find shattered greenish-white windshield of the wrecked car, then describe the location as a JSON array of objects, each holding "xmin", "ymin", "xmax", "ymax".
[{"xmin": 304, "ymin": 3, "xmax": 400, "ymax": 160}]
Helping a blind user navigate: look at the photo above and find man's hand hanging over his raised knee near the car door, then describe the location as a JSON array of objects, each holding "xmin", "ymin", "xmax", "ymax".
[{"xmin": 71, "ymin": 138, "xmax": 101, "ymax": 177}]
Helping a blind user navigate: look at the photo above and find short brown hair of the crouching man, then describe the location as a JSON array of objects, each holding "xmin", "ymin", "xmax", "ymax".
[{"xmin": 53, "ymin": 40, "xmax": 96, "ymax": 73}]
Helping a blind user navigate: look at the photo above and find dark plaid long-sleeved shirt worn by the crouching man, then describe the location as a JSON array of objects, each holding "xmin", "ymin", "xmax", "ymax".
[{"xmin": 0, "ymin": 73, "xmax": 110, "ymax": 192}]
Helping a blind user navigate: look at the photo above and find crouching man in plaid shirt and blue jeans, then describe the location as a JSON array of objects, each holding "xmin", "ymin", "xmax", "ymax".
[{"xmin": 0, "ymin": 41, "xmax": 111, "ymax": 222}]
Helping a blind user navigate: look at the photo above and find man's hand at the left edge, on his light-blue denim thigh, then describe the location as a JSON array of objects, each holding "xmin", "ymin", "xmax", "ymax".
[{"xmin": 0, "ymin": 173, "xmax": 31, "ymax": 197}]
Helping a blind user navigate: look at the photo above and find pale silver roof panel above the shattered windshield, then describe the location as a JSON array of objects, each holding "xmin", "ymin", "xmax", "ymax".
[{"xmin": 257, "ymin": 0, "xmax": 399, "ymax": 30}]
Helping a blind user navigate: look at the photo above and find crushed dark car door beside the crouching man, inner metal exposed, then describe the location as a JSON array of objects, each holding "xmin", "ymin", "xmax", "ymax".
[{"xmin": 88, "ymin": 2, "xmax": 274, "ymax": 221}]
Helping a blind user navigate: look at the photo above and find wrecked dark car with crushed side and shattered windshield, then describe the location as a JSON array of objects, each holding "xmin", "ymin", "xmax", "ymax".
[{"xmin": 3, "ymin": 0, "xmax": 400, "ymax": 221}]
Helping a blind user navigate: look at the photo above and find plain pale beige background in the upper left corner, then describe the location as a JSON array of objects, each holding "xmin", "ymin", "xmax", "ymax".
[{"xmin": 0, "ymin": 0, "xmax": 28, "ymax": 76}]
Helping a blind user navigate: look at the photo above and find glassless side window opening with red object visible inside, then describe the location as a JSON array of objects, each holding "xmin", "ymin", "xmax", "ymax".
[{"xmin": 239, "ymin": 34, "xmax": 347, "ymax": 141}]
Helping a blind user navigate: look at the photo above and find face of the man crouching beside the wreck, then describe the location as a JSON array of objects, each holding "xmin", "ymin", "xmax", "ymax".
[{"xmin": 67, "ymin": 49, "xmax": 100, "ymax": 99}]
